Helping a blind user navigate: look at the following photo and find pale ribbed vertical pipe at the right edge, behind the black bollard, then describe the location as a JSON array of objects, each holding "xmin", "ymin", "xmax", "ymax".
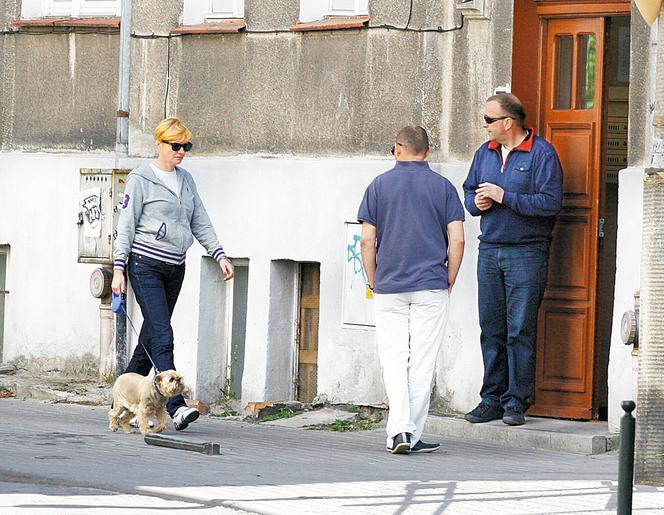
[{"xmin": 634, "ymin": 168, "xmax": 664, "ymax": 484}]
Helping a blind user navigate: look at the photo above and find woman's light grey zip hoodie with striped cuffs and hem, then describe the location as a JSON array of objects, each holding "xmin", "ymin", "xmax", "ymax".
[{"xmin": 113, "ymin": 165, "xmax": 225, "ymax": 269}]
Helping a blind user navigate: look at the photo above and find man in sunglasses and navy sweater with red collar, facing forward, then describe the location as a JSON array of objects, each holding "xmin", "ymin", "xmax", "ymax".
[{"xmin": 463, "ymin": 93, "xmax": 563, "ymax": 426}]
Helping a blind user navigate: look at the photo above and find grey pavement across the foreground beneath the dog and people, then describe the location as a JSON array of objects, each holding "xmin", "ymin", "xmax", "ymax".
[{"xmin": 0, "ymin": 399, "xmax": 664, "ymax": 515}]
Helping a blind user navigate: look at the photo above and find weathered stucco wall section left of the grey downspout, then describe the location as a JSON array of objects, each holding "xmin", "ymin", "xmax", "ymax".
[{"xmin": 0, "ymin": 6, "xmax": 118, "ymax": 151}]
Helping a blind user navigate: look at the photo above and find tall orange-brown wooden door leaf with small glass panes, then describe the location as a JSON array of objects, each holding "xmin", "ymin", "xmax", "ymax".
[{"xmin": 530, "ymin": 17, "xmax": 604, "ymax": 419}]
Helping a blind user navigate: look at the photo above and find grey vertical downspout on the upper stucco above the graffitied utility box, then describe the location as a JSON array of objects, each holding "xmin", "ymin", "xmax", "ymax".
[{"xmin": 115, "ymin": 0, "xmax": 132, "ymax": 156}]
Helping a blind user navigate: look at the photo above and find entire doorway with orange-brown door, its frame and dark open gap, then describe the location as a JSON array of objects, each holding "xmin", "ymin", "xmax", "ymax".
[{"xmin": 512, "ymin": 0, "xmax": 630, "ymax": 420}]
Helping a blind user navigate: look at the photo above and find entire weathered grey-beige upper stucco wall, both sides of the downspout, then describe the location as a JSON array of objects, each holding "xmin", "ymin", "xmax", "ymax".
[{"xmin": 0, "ymin": 0, "xmax": 512, "ymax": 160}]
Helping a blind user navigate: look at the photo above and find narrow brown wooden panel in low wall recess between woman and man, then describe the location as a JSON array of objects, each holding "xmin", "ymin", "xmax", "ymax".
[{"xmin": 297, "ymin": 263, "xmax": 320, "ymax": 402}]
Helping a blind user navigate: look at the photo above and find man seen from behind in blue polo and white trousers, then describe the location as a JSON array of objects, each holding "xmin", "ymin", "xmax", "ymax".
[{"xmin": 357, "ymin": 126, "xmax": 464, "ymax": 454}]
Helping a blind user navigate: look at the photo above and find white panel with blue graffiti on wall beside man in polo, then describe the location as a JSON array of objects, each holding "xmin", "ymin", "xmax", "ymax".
[{"xmin": 343, "ymin": 222, "xmax": 376, "ymax": 326}]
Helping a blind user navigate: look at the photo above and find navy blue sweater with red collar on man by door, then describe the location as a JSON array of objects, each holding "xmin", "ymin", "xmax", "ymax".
[{"xmin": 463, "ymin": 131, "xmax": 563, "ymax": 248}]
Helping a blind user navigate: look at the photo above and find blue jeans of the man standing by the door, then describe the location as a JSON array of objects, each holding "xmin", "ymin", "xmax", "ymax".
[{"xmin": 477, "ymin": 242, "xmax": 549, "ymax": 411}]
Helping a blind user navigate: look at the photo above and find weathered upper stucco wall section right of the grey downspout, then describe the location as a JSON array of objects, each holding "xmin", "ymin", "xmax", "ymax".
[{"xmin": 130, "ymin": 0, "xmax": 512, "ymax": 160}]
